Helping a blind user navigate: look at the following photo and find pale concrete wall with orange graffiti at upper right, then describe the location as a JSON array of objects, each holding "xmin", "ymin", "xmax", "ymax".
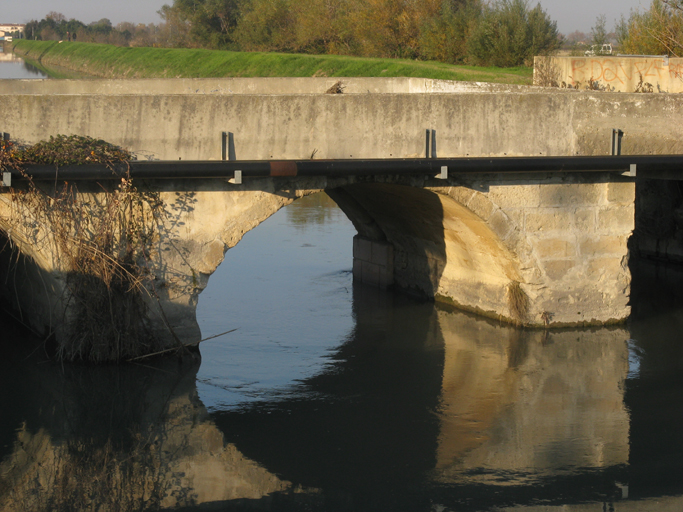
[{"xmin": 534, "ymin": 55, "xmax": 683, "ymax": 93}]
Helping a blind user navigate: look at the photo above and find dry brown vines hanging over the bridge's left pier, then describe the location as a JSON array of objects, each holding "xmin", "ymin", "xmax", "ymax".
[{"xmin": 0, "ymin": 136, "xmax": 169, "ymax": 362}]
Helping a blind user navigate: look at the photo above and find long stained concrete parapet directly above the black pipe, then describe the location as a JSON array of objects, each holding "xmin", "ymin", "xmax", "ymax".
[{"xmin": 0, "ymin": 84, "xmax": 683, "ymax": 160}]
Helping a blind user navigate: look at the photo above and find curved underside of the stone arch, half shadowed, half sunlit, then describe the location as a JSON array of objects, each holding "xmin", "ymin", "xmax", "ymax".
[{"xmin": 328, "ymin": 183, "xmax": 535, "ymax": 323}]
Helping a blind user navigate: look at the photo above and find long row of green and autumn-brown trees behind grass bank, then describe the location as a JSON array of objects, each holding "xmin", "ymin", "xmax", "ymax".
[{"xmin": 26, "ymin": 0, "xmax": 561, "ymax": 67}]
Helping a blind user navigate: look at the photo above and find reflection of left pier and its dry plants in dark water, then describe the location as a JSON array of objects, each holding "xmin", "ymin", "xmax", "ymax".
[{"xmin": 0, "ymin": 330, "xmax": 289, "ymax": 511}]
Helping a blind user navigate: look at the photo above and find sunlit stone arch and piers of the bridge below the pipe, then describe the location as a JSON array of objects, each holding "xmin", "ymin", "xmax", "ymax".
[{"xmin": 0, "ymin": 174, "xmax": 635, "ymax": 358}]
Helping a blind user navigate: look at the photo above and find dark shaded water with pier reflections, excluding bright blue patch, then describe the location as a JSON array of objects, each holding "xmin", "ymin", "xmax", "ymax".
[{"xmin": 0, "ymin": 286, "xmax": 644, "ymax": 511}]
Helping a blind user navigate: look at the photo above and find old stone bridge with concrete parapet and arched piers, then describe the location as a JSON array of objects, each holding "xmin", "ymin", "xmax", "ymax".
[{"xmin": 0, "ymin": 78, "xmax": 683, "ymax": 356}]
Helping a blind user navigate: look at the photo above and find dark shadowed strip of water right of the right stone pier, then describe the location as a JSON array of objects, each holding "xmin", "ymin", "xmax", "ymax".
[{"xmin": 625, "ymin": 260, "xmax": 683, "ymax": 496}]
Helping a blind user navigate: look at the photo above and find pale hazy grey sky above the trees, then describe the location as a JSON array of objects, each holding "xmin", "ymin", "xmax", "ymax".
[{"xmin": 0, "ymin": 0, "xmax": 650, "ymax": 35}]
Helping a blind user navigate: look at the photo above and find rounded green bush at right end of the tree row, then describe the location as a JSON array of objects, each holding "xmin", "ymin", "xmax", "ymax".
[{"xmin": 468, "ymin": 0, "xmax": 561, "ymax": 67}]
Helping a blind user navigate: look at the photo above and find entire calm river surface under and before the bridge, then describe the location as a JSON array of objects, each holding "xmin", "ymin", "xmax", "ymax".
[{"xmin": 0, "ymin": 54, "xmax": 683, "ymax": 512}]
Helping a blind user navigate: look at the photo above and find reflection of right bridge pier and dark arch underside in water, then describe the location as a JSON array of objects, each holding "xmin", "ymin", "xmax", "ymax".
[{"xmin": 212, "ymin": 287, "xmax": 629, "ymax": 510}]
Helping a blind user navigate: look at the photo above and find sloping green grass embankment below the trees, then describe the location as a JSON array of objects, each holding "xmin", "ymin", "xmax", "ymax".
[{"xmin": 14, "ymin": 39, "xmax": 533, "ymax": 85}]
